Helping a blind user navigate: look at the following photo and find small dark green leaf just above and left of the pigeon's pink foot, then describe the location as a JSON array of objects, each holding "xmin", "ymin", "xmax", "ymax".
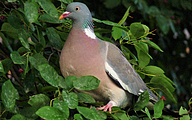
[{"xmin": 77, "ymin": 93, "xmax": 95, "ymax": 103}]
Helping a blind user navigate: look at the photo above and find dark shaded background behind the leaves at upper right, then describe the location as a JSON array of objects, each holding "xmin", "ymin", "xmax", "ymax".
[{"xmin": 74, "ymin": 0, "xmax": 192, "ymax": 109}]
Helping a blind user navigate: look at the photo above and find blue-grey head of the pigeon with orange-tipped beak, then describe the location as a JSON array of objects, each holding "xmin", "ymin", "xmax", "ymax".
[{"xmin": 59, "ymin": 2, "xmax": 93, "ymax": 29}]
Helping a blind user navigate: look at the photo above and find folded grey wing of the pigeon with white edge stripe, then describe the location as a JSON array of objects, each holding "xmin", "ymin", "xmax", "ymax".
[{"xmin": 105, "ymin": 42, "xmax": 157, "ymax": 101}]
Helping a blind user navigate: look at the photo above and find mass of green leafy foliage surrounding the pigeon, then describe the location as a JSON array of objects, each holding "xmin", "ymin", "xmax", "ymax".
[{"xmin": 0, "ymin": 0, "xmax": 192, "ymax": 120}]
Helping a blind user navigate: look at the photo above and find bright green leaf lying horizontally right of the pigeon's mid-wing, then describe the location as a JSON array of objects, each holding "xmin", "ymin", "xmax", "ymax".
[{"xmin": 143, "ymin": 66, "xmax": 165, "ymax": 75}]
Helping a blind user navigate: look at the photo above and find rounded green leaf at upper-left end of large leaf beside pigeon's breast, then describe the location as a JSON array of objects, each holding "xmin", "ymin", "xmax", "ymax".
[{"xmin": 29, "ymin": 53, "xmax": 48, "ymax": 69}]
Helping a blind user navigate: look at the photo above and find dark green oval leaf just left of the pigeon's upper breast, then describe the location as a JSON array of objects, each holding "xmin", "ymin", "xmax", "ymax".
[{"xmin": 46, "ymin": 27, "xmax": 64, "ymax": 50}]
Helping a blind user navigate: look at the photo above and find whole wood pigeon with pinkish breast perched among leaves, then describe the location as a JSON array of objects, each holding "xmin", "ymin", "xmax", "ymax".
[{"xmin": 59, "ymin": 2, "xmax": 158, "ymax": 111}]
